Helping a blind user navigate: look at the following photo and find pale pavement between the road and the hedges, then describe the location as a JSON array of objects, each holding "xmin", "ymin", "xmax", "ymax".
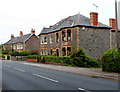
[{"xmin": 15, "ymin": 61, "xmax": 120, "ymax": 82}]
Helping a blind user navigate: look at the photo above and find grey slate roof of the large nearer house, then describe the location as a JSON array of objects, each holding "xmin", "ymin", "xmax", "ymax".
[{"xmin": 39, "ymin": 14, "xmax": 109, "ymax": 35}]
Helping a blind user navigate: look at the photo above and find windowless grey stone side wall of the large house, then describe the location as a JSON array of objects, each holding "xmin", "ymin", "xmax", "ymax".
[{"xmin": 79, "ymin": 28, "xmax": 110, "ymax": 58}]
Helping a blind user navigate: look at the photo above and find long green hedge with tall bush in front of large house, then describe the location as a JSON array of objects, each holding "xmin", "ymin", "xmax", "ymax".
[{"xmin": 27, "ymin": 48, "xmax": 100, "ymax": 68}]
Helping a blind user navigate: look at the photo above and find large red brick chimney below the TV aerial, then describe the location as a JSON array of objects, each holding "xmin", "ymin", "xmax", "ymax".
[{"xmin": 90, "ymin": 12, "xmax": 98, "ymax": 26}]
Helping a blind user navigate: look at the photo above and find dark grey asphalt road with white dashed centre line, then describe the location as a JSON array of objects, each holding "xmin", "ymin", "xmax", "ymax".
[{"xmin": 0, "ymin": 61, "xmax": 118, "ymax": 92}]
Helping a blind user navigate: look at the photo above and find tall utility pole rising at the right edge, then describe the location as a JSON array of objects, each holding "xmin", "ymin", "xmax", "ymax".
[{"xmin": 115, "ymin": 0, "xmax": 119, "ymax": 48}]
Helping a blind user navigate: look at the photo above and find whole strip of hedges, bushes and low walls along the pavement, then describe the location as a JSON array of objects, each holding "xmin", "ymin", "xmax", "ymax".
[{"xmin": 0, "ymin": 48, "xmax": 120, "ymax": 73}]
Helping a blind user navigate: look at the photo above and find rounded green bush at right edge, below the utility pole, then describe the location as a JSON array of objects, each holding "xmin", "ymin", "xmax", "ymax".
[{"xmin": 101, "ymin": 48, "xmax": 120, "ymax": 73}]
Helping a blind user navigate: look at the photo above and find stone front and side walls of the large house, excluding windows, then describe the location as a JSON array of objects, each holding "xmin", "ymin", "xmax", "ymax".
[{"xmin": 40, "ymin": 27, "xmax": 110, "ymax": 58}]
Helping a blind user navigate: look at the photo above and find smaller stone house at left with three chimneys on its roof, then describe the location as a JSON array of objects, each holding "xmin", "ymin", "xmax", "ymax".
[{"xmin": 3, "ymin": 29, "xmax": 39, "ymax": 52}]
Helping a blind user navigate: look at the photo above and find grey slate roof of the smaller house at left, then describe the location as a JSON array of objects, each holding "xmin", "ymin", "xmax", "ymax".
[{"xmin": 5, "ymin": 34, "xmax": 31, "ymax": 44}]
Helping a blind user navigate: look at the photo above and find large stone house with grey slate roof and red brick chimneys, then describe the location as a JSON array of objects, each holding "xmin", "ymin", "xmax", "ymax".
[{"xmin": 3, "ymin": 12, "xmax": 120, "ymax": 58}]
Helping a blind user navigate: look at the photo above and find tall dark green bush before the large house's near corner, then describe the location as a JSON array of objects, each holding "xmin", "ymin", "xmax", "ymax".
[{"xmin": 71, "ymin": 48, "xmax": 100, "ymax": 68}]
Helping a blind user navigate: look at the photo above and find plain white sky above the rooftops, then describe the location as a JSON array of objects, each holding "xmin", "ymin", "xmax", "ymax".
[{"xmin": 0, "ymin": 0, "xmax": 120, "ymax": 43}]
